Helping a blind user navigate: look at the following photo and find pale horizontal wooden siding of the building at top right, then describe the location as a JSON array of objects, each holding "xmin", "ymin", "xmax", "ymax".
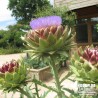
[{"xmin": 54, "ymin": 0, "xmax": 98, "ymax": 10}]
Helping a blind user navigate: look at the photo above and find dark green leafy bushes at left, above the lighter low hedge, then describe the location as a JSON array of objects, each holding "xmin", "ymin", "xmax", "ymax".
[{"xmin": 0, "ymin": 24, "xmax": 26, "ymax": 48}]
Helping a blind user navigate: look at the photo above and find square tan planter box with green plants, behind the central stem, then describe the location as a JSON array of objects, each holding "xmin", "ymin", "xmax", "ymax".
[{"xmin": 22, "ymin": 55, "xmax": 52, "ymax": 81}]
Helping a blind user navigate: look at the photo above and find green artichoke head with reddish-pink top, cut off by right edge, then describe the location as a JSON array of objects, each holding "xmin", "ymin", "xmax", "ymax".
[{"xmin": 70, "ymin": 47, "xmax": 98, "ymax": 83}]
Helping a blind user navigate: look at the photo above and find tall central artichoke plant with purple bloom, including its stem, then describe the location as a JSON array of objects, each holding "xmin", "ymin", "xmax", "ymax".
[{"xmin": 22, "ymin": 16, "xmax": 76, "ymax": 98}]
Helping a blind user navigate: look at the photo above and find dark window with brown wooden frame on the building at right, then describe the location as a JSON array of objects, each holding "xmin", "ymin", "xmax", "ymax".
[{"xmin": 76, "ymin": 17, "xmax": 98, "ymax": 45}]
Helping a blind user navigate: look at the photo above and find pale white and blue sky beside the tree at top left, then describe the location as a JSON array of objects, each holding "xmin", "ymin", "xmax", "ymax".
[{"xmin": 0, "ymin": 0, "xmax": 53, "ymax": 30}]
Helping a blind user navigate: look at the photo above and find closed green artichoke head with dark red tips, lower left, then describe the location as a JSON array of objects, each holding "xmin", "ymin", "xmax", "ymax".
[{"xmin": 0, "ymin": 60, "xmax": 27, "ymax": 91}]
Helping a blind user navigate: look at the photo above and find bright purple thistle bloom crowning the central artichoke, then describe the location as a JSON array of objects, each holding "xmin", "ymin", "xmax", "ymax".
[{"xmin": 30, "ymin": 16, "xmax": 62, "ymax": 30}]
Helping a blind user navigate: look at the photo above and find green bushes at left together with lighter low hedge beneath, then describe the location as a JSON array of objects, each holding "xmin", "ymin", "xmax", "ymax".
[{"xmin": 0, "ymin": 24, "xmax": 25, "ymax": 54}]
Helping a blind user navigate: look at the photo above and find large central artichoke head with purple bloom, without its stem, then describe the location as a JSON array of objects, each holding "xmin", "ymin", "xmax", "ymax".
[{"xmin": 22, "ymin": 16, "xmax": 75, "ymax": 57}]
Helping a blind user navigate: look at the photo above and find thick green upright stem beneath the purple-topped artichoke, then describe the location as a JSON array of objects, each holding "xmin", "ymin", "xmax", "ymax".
[{"xmin": 50, "ymin": 57, "xmax": 62, "ymax": 98}]
